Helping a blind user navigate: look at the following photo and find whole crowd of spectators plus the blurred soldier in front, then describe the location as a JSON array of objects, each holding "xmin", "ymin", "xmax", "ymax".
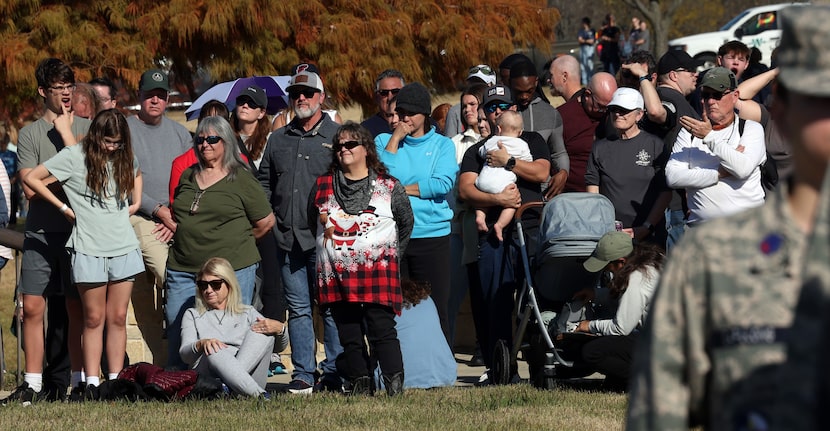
[{"xmin": 0, "ymin": 6, "xmax": 830, "ymax": 429}]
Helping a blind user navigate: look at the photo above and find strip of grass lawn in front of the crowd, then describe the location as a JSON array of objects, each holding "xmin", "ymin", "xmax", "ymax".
[{"xmin": 0, "ymin": 384, "xmax": 626, "ymax": 431}]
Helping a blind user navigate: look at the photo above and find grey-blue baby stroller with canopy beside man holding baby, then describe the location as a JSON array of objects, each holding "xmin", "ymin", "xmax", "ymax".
[{"xmin": 491, "ymin": 193, "xmax": 615, "ymax": 389}]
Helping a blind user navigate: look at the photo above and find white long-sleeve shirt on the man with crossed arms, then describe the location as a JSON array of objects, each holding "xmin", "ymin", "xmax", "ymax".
[{"xmin": 666, "ymin": 120, "xmax": 766, "ymax": 223}]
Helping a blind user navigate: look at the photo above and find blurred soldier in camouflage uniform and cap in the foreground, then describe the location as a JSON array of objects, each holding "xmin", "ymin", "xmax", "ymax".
[{"xmin": 628, "ymin": 6, "xmax": 830, "ymax": 430}]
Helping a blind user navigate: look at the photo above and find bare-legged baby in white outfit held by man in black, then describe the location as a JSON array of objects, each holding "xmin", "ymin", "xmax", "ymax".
[{"xmin": 476, "ymin": 111, "xmax": 533, "ymax": 241}]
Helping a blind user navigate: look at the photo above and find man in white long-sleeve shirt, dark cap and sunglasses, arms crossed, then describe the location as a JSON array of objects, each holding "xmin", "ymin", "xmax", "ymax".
[{"xmin": 666, "ymin": 67, "xmax": 766, "ymax": 226}]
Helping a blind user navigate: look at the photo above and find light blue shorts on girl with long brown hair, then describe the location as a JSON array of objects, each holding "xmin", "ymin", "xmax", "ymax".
[{"xmin": 70, "ymin": 249, "xmax": 144, "ymax": 284}]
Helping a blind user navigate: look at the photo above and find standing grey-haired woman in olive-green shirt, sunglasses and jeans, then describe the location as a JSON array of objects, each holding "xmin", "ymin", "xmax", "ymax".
[{"xmin": 165, "ymin": 117, "xmax": 275, "ymax": 367}]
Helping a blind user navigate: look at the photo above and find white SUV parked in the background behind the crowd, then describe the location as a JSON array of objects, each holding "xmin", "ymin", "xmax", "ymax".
[{"xmin": 669, "ymin": 3, "xmax": 807, "ymax": 69}]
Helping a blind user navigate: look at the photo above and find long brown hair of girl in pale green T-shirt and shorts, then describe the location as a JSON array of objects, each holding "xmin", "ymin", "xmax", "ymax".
[{"xmin": 83, "ymin": 109, "xmax": 135, "ymax": 200}]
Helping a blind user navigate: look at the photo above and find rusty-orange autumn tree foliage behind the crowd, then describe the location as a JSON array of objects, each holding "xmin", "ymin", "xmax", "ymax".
[{"xmin": 0, "ymin": 0, "xmax": 559, "ymax": 123}]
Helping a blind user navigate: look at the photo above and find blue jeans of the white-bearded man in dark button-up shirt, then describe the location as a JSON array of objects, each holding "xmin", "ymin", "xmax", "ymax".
[{"xmin": 277, "ymin": 243, "xmax": 343, "ymax": 385}]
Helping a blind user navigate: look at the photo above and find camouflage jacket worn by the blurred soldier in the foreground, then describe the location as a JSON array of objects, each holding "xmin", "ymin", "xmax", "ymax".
[{"xmin": 628, "ymin": 184, "xmax": 806, "ymax": 430}]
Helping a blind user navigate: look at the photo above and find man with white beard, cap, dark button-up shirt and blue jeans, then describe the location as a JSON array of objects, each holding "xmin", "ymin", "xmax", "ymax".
[{"xmin": 257, "ymin": 71, "xmax": 343, "ymax": 394}]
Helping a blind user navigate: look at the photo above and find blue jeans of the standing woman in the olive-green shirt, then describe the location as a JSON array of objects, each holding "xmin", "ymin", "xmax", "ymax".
[{"xmin": 164, "ymin": 262, "xmax": 259, "ymax": 370}]
